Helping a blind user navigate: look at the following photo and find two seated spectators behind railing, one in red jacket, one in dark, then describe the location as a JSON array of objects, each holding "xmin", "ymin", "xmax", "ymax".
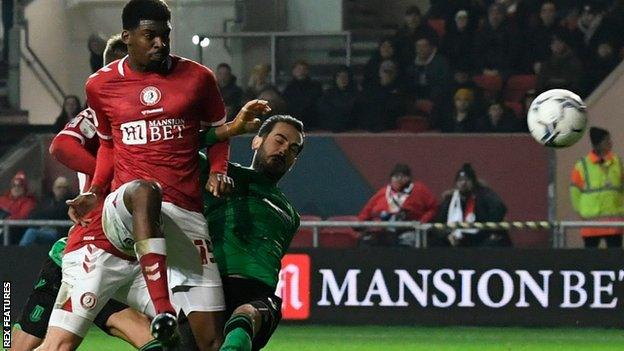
[{"xmin": 357, "ymin": 163, "xmax": 511, "ymax": 247}]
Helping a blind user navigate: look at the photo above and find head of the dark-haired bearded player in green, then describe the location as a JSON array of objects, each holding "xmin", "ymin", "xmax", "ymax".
[{"xmin": 251, "ymin": 115, "xmax": 305, "ymax": 181}]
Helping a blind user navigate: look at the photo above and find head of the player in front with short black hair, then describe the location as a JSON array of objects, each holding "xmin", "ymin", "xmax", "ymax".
[{"xmin": 121, "ymin": 0, "xmax": 171, "ymax": 71}]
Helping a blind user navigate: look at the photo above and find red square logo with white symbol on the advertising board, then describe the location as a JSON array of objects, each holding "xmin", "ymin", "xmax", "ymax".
[{"xmin": 275, "ymin": 254, "xmax": 310, "ymax": 320}]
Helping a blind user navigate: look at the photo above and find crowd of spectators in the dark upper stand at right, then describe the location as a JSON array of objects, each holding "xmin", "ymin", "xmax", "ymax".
[{"xmin": 218, "ymin": 0, "xmax": 624, "ymax": 133}]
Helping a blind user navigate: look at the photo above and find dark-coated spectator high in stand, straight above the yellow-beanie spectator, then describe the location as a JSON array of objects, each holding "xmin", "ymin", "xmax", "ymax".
[{"xmin": 440, "ymin": 10, "xmax": 474, "ymax": 72}]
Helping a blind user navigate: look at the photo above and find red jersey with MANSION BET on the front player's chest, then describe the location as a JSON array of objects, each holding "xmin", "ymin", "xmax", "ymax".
[{"xmin": 86, "ymin": 56, "xmax": 225, "ymax": 212}]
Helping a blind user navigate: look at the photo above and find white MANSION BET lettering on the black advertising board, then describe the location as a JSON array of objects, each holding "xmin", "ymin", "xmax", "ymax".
[{"xmin": 317, "ymin": 268, "xmax": 624, "ymax": 309}]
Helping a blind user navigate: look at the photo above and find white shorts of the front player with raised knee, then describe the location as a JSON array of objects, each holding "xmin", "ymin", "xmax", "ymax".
[{"xmin": 102, "ymin": 183, "xmax": 225, "ymax": 313}]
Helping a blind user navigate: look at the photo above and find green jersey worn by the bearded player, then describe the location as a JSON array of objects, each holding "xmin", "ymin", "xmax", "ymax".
[{"xmin": 200, "ymin": 155, "xmax": 299, "ymax": 288}]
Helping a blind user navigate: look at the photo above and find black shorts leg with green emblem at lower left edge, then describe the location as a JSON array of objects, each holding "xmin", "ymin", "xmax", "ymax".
[{"xmin": 17, "ymin": 257, "xmax": 62, "ymax": 339}]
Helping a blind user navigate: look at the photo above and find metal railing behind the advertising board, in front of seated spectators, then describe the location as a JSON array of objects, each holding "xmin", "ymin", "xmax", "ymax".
[{"xmin": 0, "ymin": 219, "xmax": 624, "ymax": 249}]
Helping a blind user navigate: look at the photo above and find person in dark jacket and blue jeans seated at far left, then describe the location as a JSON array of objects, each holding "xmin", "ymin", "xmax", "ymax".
[{"xmin": 20, "ymin": 177, "xmax": 73, "ymax": 246}]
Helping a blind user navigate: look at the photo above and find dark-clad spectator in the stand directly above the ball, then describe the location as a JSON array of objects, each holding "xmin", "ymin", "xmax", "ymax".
[{"xmin": 537, "ymin": 30, "xmax": 583, "ymax": 92}]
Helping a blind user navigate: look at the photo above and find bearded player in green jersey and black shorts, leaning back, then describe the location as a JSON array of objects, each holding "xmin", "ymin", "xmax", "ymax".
[{"xmin": 201, "ymin": 115, "xmax": 304, "ymax": 350}]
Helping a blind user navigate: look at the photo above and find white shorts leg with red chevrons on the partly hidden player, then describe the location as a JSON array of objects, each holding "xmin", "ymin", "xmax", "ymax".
[{"xmin": 49, "ymin": 244, "xmax": 138, "ymax": 338}]
